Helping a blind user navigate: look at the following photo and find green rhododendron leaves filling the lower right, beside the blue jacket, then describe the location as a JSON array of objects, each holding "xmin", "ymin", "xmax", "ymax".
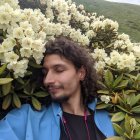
[{"xmin": 97, "ymin": 70, "xmax": 140, "ymax": 140}]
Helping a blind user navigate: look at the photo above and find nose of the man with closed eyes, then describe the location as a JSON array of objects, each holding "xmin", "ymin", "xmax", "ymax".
[{"xmin": 43, "ymin": 72, "xmax": 55, "ymax": 86}]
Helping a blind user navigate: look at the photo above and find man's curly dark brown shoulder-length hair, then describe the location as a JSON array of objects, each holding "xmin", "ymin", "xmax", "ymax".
[{"xmin": 45, "ymin": 36, "xmax": 98, "ymax": 105}]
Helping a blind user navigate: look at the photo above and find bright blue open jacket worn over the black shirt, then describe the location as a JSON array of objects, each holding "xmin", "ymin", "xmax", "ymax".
[{"xmin": 0, "ymin": 99, "xmax": 115, "ymax": 140}]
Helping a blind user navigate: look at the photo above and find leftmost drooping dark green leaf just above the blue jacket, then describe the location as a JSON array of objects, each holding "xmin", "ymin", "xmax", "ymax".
[{"xmin": 2, "ymin": 94, "xmax": 12, "ymax": 110}]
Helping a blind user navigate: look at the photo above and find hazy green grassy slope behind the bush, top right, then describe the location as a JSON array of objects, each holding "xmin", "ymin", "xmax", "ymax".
[{"xmin": 73, "ymin": 0, "xmax": 140, "ymax": 42}]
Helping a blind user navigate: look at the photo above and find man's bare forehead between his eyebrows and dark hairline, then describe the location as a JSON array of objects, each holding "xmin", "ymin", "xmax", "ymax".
[{"xmin": 43, "ymin": 54, "xmax": 74, "ymax": 68}]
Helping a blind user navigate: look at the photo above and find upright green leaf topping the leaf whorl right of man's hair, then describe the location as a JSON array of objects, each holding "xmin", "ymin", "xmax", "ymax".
[{"xmin": 104, "ymin": 70, "xmax": 114, "ymax": 88}]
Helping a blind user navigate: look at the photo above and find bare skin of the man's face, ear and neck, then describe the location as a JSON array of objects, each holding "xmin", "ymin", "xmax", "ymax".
[{"xmin": 43, "ymin": 54, "xmax": 86, "ymax": 116}]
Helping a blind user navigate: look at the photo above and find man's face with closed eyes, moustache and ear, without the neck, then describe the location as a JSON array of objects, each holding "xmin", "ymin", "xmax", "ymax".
[{"xmin": 43, "ymin": 54, "xmax": 83, "ymax": 102}]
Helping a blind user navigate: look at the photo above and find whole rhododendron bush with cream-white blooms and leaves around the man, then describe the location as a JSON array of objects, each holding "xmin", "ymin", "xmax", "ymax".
[{"xmin": 0, "ymin": 0, "xmax": 140, "ymax": 140}]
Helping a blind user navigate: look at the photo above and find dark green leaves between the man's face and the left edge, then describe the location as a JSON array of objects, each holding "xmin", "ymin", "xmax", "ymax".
[{"xmin": 0, "ymin": 62, "xmax": 48, "ymax": 110}]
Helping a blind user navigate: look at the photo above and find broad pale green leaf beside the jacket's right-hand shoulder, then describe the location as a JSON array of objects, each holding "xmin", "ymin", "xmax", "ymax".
[{"xmin": 111, "ymin": 112, "xmax": 125, "ymax": 122}]
